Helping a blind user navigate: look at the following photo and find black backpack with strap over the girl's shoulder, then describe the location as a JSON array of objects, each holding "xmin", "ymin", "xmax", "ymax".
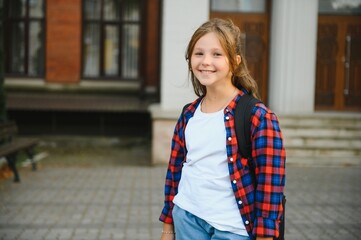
[{"xmin": 234, "ymin": 94, "xmax": 286, "ymax": 240}]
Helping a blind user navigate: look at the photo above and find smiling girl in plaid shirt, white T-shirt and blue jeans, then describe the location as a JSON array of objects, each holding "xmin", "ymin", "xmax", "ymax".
[{"xmin": 160, "ymin": 19, "xmax": 285, "ymax": 240}]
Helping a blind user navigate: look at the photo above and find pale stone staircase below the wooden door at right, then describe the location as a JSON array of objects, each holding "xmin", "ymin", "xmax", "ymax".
[{"xmin": 279, "ymin": 113, "xmax": 361, "ymax": 166}]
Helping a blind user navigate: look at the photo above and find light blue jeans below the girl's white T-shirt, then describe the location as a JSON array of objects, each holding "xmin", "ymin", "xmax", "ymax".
[{"xmin": 173, "ymin": 205, "xmax": 250, "ymax": 240}]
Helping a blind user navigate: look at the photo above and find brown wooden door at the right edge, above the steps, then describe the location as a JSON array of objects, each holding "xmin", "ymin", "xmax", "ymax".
[{"xmin": 315, "ymin": 15, "xmax": 361, "ymax": 111}]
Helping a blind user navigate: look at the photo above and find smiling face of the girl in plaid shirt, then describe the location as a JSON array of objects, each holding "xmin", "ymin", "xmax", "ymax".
[{"xmin": 191, "ymin": 32, "xmax": 232, "ymax": 87}]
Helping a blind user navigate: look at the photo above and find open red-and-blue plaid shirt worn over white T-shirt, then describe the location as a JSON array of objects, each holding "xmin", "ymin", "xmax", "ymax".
[{"xmin": 159, "ymin": 90, "xmax": 286, "ymax": 239}]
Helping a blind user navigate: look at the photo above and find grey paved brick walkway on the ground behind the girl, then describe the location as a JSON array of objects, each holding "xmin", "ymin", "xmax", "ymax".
[{"xmin": 0, "ymin": 138, "xmax": 361, "ymax": 240}]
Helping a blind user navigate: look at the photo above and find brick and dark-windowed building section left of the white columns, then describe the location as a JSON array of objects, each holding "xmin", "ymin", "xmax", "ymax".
[{"xmin": 2, "ymin": 0, "xmax": 161, "ymax": 135}]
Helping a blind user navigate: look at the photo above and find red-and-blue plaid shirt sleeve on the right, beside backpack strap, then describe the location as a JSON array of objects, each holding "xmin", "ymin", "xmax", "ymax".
[{"xmin": 251, "ymin": 107, "xmax": 286, "ymax": 237}]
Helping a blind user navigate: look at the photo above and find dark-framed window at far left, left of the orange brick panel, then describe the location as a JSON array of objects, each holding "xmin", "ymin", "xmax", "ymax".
[{"xmin": 4, "ymin": 0, "xmax": 45, "ymax": 77}]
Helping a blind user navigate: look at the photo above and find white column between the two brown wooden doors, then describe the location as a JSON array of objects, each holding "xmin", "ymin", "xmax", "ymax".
[{"xmin": 269, "ymin": 0, "xmax": 318, "ymax": 114}]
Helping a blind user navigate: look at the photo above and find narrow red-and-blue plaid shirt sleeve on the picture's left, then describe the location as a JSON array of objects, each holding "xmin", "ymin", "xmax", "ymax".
[{"xmin": 159, "ymin": 113, "xmax": 185, "ymax": 224}]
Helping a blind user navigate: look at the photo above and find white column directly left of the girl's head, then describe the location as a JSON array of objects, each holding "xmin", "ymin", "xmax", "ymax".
[{"xmin": 161, "ymin": 0, "xmax": 209, "ymax": 110}]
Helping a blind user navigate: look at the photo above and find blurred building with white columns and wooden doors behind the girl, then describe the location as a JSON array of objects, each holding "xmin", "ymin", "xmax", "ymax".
[{"xmin": 3, "ymin": 0, "xmax": 361, "ymax": 163}]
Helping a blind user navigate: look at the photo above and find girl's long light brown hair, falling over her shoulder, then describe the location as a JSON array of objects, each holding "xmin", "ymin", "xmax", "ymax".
[{"xmin": 186, "ymin": 18, "xmax": 260, "ymax": 99}]
